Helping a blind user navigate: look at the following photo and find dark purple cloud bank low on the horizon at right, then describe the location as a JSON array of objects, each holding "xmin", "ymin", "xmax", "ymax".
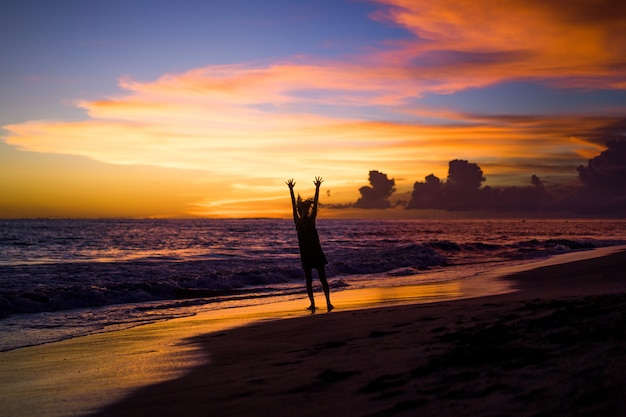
[{"xmin": 330, "ymin": 139, "xmax": 626, "ymax": 216}]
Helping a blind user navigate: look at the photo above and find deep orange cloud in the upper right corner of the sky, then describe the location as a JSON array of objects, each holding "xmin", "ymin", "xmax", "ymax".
[{"xmin": 373, "ymin": 0, "xmax": 626, "ymax": 92}]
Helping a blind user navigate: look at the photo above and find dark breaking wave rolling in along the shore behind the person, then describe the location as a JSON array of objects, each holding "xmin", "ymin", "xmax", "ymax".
[{"xmin": 0, "ymin": 234, "xmax": 624, "ymax": 317}]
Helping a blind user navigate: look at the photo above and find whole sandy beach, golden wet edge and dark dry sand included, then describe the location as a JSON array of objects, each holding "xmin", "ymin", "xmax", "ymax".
[{"xmin": 0, "ymin": 250, "xmax": 626, "ymax": 416}]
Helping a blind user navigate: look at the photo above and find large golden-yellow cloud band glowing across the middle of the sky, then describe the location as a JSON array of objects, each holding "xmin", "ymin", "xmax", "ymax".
[{"xmin": 5, "ymin": 61, "xmax": 611, "ymax": 215}]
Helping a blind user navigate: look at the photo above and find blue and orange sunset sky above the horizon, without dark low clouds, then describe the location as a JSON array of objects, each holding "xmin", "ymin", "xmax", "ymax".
[{"xmin": 0, "ymin": 0, "xmax": 626, "ymax": 218}]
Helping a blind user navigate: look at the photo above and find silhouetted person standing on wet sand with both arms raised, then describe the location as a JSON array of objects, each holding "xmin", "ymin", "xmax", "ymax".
[{"xmin": 286, "ymin": 177, "xmax": 333, "ymax": 312}]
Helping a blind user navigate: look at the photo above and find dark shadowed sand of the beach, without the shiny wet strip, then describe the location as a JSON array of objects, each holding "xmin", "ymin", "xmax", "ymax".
[{"xmin": 81, "ymin": 252, "xmax": 626, "ymax": 417}]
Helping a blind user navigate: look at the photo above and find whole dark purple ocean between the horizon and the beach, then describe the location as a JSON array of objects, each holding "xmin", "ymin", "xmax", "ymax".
[{"xmin": 0, "ymin": 219, "xmax": 626, "ymax": 351}]
